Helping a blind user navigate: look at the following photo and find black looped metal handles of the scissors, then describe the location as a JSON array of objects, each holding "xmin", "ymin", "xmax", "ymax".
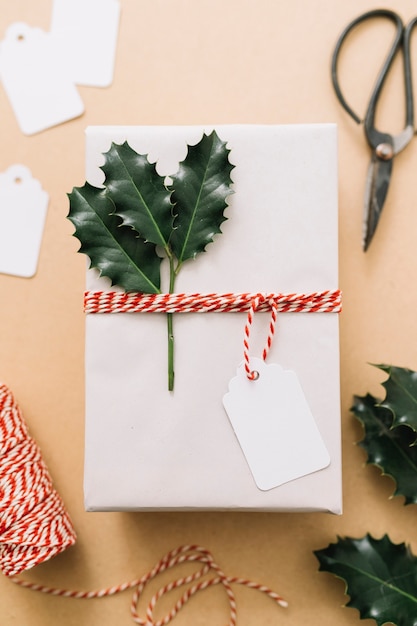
[{"xmin": 331, "ymin": 9, "xmax": 404, "ymax": 134}]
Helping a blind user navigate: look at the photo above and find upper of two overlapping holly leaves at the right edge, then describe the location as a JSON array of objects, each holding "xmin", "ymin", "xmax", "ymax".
[{"xmin": 376, "ymin": 365, "xmax": 417, "ymax": 439}]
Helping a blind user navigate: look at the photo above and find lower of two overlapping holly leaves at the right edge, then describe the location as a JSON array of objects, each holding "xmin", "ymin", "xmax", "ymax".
[{"xmin": 351, "ymin": 394, "xmax": 417, "ymax": 504}]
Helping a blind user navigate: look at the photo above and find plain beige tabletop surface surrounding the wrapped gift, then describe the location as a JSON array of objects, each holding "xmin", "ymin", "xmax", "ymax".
[{"xmin": 0, "ymin": 0, "xmax": 417, "ymax": 626}]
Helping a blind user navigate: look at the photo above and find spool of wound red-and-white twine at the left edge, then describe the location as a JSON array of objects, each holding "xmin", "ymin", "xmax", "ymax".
[{"xmin": 0, "ymin": 383, "xmax": 76, "ymax": 576}]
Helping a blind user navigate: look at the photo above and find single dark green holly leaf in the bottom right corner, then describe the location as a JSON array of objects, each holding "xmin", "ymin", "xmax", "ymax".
[{"xmin": 314, "ymin": 534, "xmax": 417, "ymax": 626}]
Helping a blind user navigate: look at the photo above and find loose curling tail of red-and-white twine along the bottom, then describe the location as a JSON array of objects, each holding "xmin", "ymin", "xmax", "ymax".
[{"xmin": 13, "ymin": 545, "xmax": 288, "ymax": 626}]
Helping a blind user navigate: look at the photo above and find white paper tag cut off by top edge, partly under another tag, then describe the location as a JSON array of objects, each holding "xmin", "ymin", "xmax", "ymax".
[{"xmin": 51, "ymin": 0, "xmax": 120, "ymax": 87}]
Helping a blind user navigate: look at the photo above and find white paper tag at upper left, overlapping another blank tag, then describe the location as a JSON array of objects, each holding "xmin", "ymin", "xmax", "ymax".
[{"xmin": 0, "ymin": 23, "xmax": 84, "ymax": 135}]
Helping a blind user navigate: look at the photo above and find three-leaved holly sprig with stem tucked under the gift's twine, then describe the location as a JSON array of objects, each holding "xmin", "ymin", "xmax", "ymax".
[{"xmin": 68, "ymin": 131, "xmax": 234, "ymax": 391}]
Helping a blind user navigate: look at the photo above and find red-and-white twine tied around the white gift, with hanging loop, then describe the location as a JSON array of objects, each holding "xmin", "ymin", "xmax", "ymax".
[{"xmin": 84, "ymin": 289, "xmax": 342, "ymax": 380}]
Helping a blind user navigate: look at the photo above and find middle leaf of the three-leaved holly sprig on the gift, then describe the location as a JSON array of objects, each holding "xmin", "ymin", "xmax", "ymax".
[{"xmin": 101, "ymin": 142, "xmax": 173, "ymax": 248}]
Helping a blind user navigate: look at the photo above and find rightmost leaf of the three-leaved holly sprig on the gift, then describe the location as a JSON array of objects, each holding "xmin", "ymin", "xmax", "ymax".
[{"xmin": 170, "ymin": 131, "xmax": 233, "ymax": 265}]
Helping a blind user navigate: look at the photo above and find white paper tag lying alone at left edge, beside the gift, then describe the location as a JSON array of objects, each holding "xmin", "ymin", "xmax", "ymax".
[{"xmin": 0, "ymin": 165, "xmax": 49, "ymax": 278}]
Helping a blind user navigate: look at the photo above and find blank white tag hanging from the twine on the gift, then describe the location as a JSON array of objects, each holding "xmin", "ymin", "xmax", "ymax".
[{"xmin": 223, "ymin": 358, "xmax": 330, "ymax": 491}]
